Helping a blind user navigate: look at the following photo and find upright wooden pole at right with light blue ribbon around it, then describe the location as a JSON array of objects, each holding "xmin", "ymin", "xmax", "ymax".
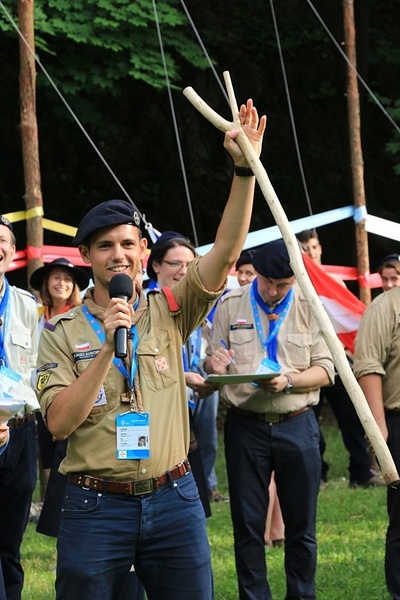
[{"xmin": 343, "ymin": 0, "xmax": 371, "ymax": 304}]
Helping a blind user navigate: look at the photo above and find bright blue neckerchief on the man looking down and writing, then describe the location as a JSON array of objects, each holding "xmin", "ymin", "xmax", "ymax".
[{"xmin": 250, "ymin": 278, "xmax": 294, "ymax": 362}]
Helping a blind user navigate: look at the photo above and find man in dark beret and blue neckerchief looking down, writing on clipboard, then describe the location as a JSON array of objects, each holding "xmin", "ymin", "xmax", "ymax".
[{"xmin": 205, "ymin": 240, "xmax": 334, "ymax": 600}]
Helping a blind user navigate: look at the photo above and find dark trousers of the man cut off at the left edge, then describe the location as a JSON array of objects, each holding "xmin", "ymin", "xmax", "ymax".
[{"xmin": 0, "ymin": 418, "xmax": 37, "ymax": 600}]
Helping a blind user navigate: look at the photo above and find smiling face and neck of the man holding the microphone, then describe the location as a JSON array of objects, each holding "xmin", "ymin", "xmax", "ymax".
[{"xmin": 79, "ymin": 225, "xmax": 147, "ymax": 306}]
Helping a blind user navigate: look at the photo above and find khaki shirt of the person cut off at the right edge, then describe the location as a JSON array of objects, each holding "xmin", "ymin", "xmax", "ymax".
[{"xmin": 353, "ymin": 288, "xmax": 400, "ymax": 410}]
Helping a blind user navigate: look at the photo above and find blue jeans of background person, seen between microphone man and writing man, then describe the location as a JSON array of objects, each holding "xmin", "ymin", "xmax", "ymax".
[{"xmin": 192, "ymin": 392, "xmax": 219, "ymax": 492}]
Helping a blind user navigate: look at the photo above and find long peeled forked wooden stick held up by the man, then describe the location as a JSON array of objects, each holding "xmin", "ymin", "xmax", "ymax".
[{"xmin": 183, "ymin": 71, "xmax": 400, "ymax": 487}]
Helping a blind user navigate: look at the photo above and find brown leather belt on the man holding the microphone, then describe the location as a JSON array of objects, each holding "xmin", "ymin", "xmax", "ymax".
[{"xmin": 67, "ymin": 459, "xmax": 191, "ymax": 496}]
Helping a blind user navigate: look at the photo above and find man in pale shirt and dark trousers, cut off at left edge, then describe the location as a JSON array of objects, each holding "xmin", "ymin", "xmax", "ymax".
[{"xmin": 0, "ymin": 216, "xmax": 39, "ymax": 600}]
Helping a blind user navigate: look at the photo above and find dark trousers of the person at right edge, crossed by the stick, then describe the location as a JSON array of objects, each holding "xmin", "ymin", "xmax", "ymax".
[{"xmin": 385, "ymin": 411, "xmax": 400, "ymax": 600}]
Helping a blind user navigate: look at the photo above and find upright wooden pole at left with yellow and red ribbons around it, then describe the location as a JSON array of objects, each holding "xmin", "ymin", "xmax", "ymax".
[{"xmin": 18, "ymin": 0, "xmax": 43, "ymax": 288}]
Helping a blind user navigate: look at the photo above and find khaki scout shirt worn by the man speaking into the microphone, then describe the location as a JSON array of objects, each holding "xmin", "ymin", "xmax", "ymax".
[{"xmin": 37, "ymin": 259, "xmax": 223, "ymax": 481}]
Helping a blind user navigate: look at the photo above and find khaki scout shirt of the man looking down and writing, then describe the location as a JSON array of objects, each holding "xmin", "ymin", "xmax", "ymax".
[{"xmin": 207, "ymin": 284, "xmax": 334, "ymax": 413}]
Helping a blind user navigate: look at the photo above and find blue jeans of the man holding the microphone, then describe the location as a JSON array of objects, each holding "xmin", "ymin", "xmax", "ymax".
[{"xmin": 56, "ymin": 473, "xmax": 213, "ymax": 600}]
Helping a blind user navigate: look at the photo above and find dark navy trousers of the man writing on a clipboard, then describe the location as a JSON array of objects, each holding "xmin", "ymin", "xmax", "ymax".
[{"xmin": 225, "ymin": 410, "xmax": 321, "ymax": 600}]
